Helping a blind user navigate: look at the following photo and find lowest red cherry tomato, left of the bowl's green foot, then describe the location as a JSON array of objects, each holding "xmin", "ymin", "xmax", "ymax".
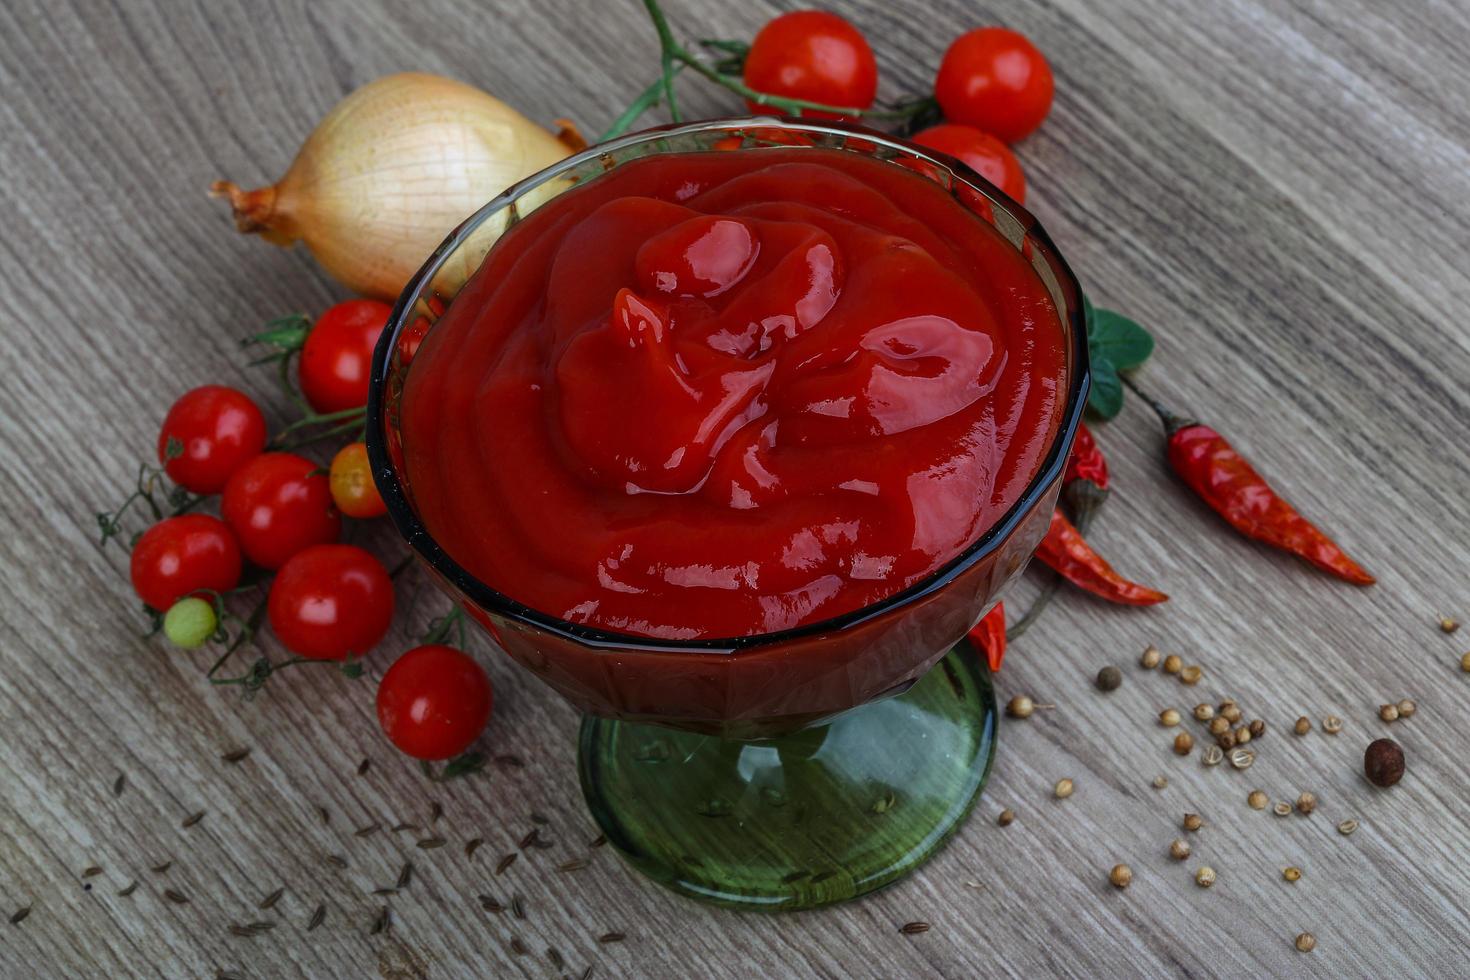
[{"xmin": 378, "ymin": 645, "xmax": 492, "ymax": 761}]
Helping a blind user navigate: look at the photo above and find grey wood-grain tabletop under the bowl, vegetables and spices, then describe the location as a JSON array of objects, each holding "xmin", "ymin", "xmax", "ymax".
[{"xmin": 0, "ymin": 0, "xmax": 1470, "ymax": 977}]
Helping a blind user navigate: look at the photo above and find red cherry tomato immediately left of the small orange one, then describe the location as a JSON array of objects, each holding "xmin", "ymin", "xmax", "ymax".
[{"xmin": 219, "ymin": 453, "xmax": 343, "ymax": 569}]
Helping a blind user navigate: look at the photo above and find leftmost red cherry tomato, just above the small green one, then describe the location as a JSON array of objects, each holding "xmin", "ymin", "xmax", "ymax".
[{"xmin": 129, "ymin": 514, "xmax": 240, "ymax": 613}]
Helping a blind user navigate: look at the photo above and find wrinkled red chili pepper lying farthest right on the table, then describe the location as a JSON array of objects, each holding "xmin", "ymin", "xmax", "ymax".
[{"xmin": 1155, "ymin": 420, "xmax": 1374, "ymax": 585}]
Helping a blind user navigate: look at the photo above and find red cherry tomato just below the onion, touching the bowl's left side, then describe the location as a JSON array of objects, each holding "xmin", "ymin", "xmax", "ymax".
[{"xmin": 300, "ymin": 300, "xmax": 392, "ymax": 413}]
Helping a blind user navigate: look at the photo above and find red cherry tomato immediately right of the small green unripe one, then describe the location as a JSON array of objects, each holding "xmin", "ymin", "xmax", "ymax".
[{"xmin": 266, "ymin": 545, "xmax": 392, "ymax": 660}]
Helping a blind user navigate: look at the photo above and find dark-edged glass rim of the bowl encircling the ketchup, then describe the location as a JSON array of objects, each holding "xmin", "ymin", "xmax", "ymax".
[{"xmin": 366, "ymin": 116, "xmax": 1091, "ymax": 654}]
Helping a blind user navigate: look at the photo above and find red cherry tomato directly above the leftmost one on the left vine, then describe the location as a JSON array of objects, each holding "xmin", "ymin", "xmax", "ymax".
[{"xmin": 159, "ymin": 385, "xmax": 266, "ymax": 494}]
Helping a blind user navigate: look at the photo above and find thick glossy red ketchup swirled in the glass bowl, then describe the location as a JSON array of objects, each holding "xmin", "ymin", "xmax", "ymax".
[{"xmin": 401, "ymin": 148, "xmax": 1066, "ymax": 639}]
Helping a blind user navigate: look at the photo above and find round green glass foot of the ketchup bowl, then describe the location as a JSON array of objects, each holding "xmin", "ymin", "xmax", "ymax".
[{"xmin": 581, "ymin": 646, "xmax": 995, "ymax": 909}]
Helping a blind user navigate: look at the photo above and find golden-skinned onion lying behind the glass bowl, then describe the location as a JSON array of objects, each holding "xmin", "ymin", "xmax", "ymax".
[{"xmin": 210, "ymin": 72, "xmax": 569, "ymax": 300}]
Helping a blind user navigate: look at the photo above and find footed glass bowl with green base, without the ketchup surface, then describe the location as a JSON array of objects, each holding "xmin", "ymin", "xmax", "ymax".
[{"xmin": 368, "ymin": 118, "xmax": 1088, "ymax": 908}]
